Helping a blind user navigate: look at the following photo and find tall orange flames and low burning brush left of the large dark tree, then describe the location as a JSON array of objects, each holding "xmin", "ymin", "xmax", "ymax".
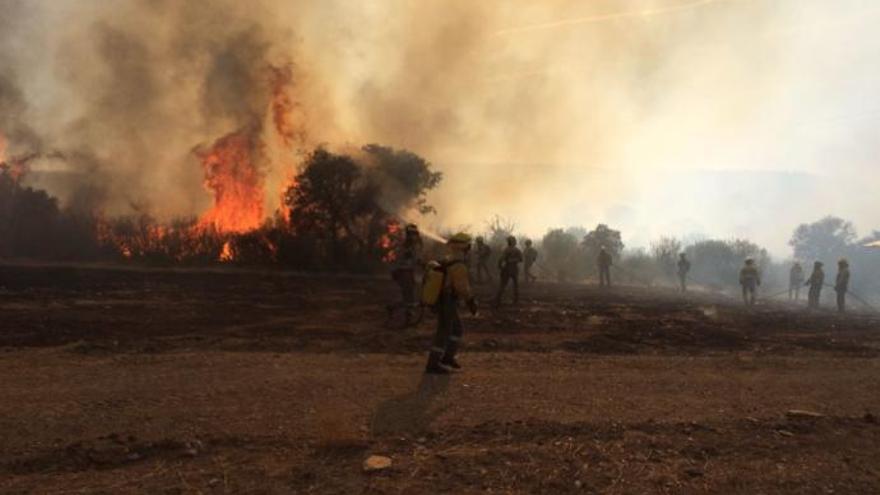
[{"xmin": 89, "ymin": 67, "xmax": 305, "ymax": 262}]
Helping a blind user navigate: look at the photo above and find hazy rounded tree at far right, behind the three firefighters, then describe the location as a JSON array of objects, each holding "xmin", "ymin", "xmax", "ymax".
[{"xmin": 788, "ymin": 216, "xmax": 856, "ymax": 263}]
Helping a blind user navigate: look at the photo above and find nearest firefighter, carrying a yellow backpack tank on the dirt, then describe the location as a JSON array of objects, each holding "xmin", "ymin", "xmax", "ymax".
[{"xmin": 425, "ymin": 233, "xmax": 477, "ymax": 375}]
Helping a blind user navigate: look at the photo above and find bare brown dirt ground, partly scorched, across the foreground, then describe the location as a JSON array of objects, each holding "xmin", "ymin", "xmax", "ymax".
[{"xmin": 0, "ymin": 265, "xmax": 880, "ymax": 494}]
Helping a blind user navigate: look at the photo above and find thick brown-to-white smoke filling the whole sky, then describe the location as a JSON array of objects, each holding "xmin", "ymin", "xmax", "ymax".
[{"xmin": 0, "ymin": 0, "xmax": 880, "ymax": 254}]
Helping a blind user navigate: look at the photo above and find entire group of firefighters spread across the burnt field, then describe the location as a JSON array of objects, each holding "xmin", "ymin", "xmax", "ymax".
[{"xmin": 389, "ymin": 224, "xmax": 850, "ymax": 374}]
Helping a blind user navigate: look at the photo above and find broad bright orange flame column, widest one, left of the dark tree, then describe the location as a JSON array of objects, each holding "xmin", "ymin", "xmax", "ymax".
[{"xmin": 196, "ymin": 128, "xmax": 265, "ymax": 233}]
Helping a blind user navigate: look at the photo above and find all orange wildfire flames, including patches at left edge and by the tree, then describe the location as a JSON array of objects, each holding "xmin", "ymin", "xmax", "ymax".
[{"xmin": 0, "ymin": 61, "xmax": 403, "ymax": 263}]
